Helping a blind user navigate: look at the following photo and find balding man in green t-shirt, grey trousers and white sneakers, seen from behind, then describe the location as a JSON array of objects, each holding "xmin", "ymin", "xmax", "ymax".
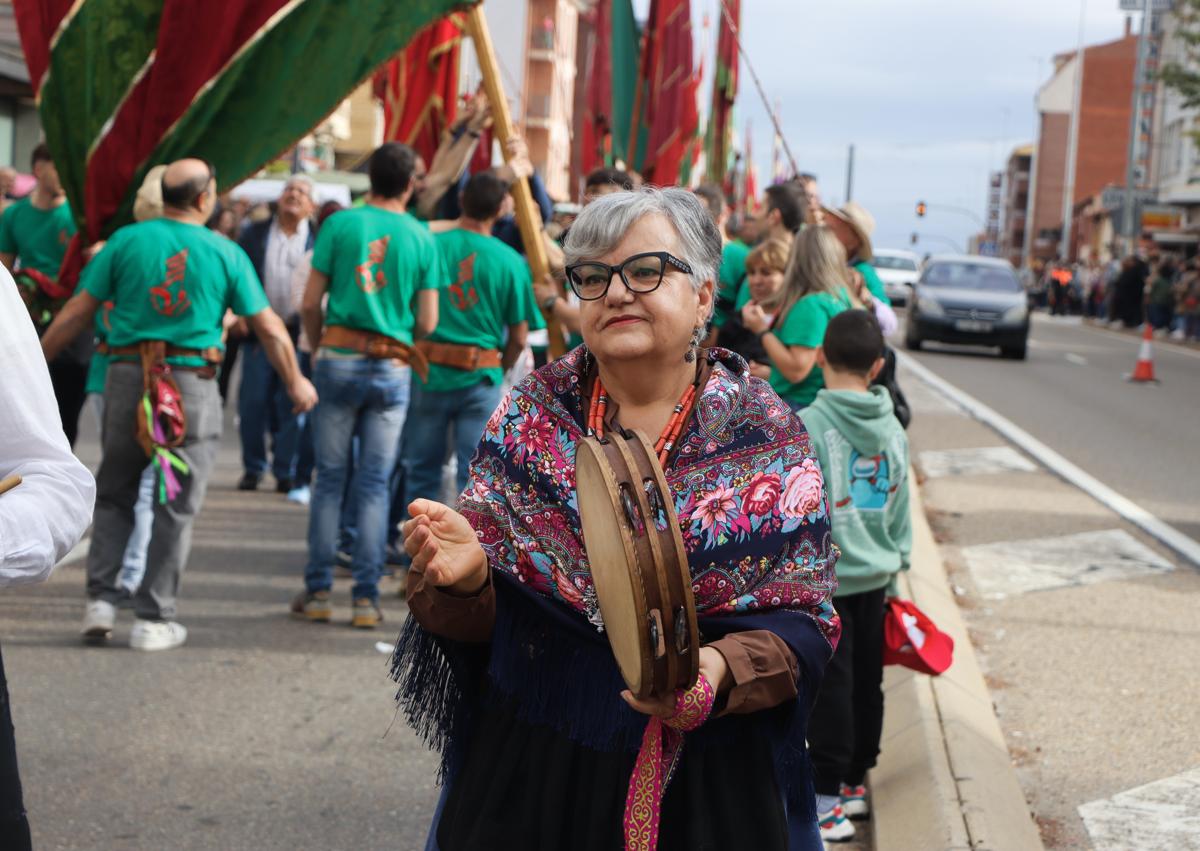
[{"xmin": 42, "ymin": 160, "xmax": 317, "ymax": 651}]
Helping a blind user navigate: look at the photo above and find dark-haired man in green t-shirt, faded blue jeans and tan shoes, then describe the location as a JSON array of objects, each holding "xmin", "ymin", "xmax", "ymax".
[{"xmin": 292, "ymin": 142, "xmax": 446, "ymax": 629}]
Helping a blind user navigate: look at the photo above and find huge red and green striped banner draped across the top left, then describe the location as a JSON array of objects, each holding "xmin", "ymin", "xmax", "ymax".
[{"xmin": 13, "ymin": 0, "xmax": 470, "ymax": 252}]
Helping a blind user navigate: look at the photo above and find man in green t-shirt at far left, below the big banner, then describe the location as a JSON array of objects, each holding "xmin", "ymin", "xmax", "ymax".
[{"xmin": 0, "ymin": 143, "xmax": 92, "ymax": 445}]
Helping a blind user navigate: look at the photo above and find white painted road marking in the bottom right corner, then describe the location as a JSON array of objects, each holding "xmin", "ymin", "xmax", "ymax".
[{"xmin": 1079, "ymin": 768, "xmax": 1200, "ymax": 851}]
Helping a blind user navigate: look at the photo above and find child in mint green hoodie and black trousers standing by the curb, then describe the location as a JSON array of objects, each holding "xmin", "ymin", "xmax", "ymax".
[{"xmin": 800, "ymin": 310, "xmax": 912, "ymax": 841}]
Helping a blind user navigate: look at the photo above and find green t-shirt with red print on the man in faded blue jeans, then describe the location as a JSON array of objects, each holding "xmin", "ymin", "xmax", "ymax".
[{"xmin": 312, "ymin": 204, "xmax": 446, "ymax": 346}]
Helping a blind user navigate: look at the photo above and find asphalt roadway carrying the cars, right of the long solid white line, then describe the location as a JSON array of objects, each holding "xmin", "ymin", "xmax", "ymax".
[{"xmin": 896, "ymin": 314, "xmax": 1200, "ymax": 540}]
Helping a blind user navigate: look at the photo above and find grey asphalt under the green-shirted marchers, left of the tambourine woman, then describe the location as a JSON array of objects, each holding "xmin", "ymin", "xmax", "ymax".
[{"xmin": 0, "ymin": 408, "xmax": 436, "ymax": 851}]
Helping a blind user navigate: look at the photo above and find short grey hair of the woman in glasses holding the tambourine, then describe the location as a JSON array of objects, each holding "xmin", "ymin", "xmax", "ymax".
[{"xmin": 563, "ymin": 186, "xmax": 721, "ymax": 290}]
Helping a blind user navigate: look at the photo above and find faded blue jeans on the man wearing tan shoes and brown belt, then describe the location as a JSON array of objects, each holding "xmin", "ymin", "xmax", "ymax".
[{"xmin": 305, "ymin": 358, "xmax": 412, "ymax": 600}]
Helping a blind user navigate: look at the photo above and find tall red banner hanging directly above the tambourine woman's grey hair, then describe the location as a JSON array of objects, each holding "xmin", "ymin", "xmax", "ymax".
[{"xmin": 630, "ymin": 0, "xmax": 698, "ymax": 186}]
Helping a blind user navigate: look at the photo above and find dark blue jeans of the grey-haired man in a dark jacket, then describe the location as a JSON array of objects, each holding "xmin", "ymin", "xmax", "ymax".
[{"xmin": 238, "ymin": 340, "xmax": 306, "ymax": 480}]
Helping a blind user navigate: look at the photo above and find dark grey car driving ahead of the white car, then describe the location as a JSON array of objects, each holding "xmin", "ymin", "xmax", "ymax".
[{"xmin": 905, "ymin": 254, "xmax": 1030, "ymax": 360}]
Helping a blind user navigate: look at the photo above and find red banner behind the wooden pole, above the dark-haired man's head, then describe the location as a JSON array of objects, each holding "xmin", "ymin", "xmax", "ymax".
[{"xmin": 374, "ymin": 14, "xmax": 466, "ymax": 163}]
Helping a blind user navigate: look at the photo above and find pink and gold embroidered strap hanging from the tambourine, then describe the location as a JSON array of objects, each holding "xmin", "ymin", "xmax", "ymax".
[{"xmin": 625, "ymin": 677, "xmax": 716, "ymax": 851}]
